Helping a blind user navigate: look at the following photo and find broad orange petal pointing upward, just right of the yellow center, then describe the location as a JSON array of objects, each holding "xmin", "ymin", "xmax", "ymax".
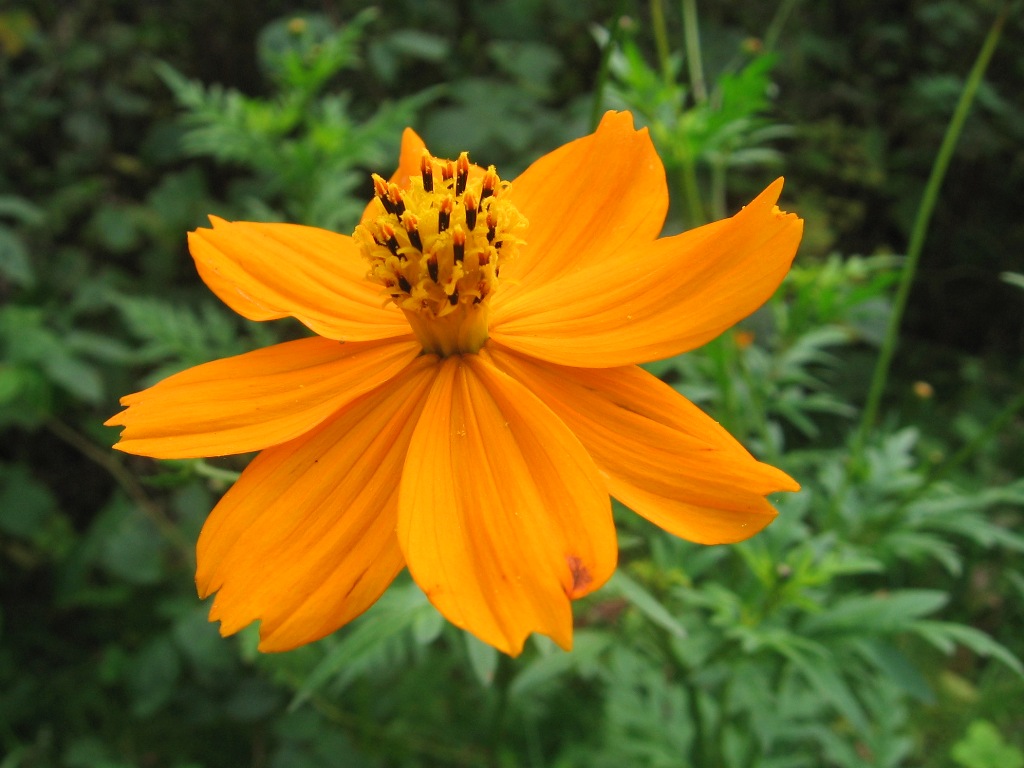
[{"xmin": 502, "ymin": 112, "xmax": 669, "ymax": 296}]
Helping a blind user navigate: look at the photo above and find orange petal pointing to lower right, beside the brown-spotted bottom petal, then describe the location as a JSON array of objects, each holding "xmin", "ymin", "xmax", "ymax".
[{"xmin": 487, "ymin": 344, "xmax": 800, "ymax": 544}]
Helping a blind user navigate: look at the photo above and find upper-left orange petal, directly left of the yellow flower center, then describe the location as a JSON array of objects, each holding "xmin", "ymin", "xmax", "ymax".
[{"xmin": 188, "ymin": 216, "xmax": 409, "ymax": 341}]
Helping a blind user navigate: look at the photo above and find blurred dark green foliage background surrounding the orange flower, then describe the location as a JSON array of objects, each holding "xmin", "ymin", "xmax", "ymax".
[{"xmin": 0, "ymin": 0, "xmax": 1024, "ymax": 768}]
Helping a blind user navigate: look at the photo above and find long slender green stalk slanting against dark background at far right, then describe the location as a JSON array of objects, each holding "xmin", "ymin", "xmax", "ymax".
[{"xmin": 851, "ymin": 4, "xmax": 1009, "ymax": 465}]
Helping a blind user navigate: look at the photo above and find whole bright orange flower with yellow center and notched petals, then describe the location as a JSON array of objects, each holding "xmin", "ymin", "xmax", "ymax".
[{"xmin": 108, "ymin": 113, "xmax": 802, "ymax": 654}]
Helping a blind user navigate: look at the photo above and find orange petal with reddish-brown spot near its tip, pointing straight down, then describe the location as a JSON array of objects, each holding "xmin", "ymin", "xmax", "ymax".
[{"xmin": 398, "ymin": 354, "xmax": 617, "ymax": 655}]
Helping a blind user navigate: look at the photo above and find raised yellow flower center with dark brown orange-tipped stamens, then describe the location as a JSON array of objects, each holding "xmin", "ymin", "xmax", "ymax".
[{"xmin": 353, "ymin": 151, "xmax": 526, "ymax": 356}]
